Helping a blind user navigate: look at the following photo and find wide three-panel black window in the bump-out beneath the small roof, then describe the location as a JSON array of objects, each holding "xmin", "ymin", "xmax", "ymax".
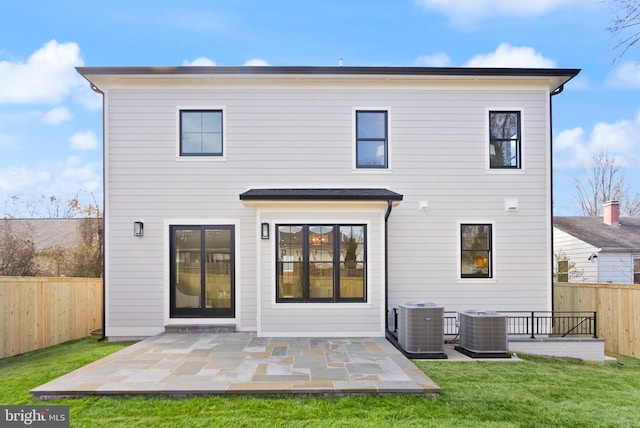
[{"xmin": 276, "ymin": 224, "xmax": 367, "ymax": 303}]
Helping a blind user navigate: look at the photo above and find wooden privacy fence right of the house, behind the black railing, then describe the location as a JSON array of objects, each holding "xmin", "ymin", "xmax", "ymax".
[{"xmin": 554, "ymin": 282, "xmax": 640, "ymax": 358}]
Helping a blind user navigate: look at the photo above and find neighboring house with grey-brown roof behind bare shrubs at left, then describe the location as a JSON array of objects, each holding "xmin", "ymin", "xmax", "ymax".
[{"xmin": 0, "ymin": 218, "xmax": 84, "ymax": 276}]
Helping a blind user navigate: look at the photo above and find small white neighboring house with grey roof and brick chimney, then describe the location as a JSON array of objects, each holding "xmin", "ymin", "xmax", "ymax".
[{"xmin": 553, "ymin": 201, "xmax": 640, "ymax": 284}]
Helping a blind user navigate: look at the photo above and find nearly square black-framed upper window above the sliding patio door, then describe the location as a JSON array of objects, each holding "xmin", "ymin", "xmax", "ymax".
[{"xmin": 180, "ymin": 110, "xmax": 224, "ymax": 156}]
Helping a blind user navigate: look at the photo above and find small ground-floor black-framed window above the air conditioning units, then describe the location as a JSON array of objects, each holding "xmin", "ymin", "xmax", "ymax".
[{"xmin": 460, "ymin": 224, "xmax": 493, "ymax": 278}]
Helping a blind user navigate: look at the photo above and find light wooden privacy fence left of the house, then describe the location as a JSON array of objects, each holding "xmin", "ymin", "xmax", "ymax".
[{"xmin": 0, "ymin": 277, "xmax": 102, "ymax": 358}]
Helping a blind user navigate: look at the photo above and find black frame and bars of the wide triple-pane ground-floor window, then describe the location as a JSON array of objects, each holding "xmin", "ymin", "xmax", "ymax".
[{"xmin": 274, "ymin": 223, "xmax": 368, "ymax": 303}]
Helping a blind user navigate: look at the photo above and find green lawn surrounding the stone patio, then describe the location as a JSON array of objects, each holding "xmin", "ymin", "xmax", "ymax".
[{"xmin": 0, "ymin": 338, "xmax": 640, "ymax": 428}]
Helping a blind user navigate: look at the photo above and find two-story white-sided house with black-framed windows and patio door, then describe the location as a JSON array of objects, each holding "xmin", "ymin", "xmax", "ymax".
[{"xmin": 78, "ymin": 63, "xmax": 579, "ymax": 339}]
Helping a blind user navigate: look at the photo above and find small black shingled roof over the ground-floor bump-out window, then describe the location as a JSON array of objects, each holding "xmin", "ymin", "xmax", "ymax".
[{"xmin": 240, "ymin": 188, "xmax": 402, "ymax": 201}]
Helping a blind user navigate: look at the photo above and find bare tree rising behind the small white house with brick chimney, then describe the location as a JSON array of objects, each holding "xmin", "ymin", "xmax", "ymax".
[{"xmin": 576, "ymin": 150, "xmax": 640, "ymax": 216}]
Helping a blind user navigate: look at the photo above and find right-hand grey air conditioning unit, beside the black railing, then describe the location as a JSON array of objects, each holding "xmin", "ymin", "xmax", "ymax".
[{"xmin": 455, "ymin": 310, "xmax": 510, "ymax": 358}]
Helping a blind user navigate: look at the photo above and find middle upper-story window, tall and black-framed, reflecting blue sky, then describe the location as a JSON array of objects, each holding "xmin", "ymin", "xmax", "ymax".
[{"xmin": 356, "ymin": 110, "xmax": 389, "ymax": 168}]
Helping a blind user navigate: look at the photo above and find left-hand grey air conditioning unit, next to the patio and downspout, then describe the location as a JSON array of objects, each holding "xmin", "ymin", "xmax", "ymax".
[{"xmin": 398, "ymin": 302, "xmax": 446, "ymax": 357}]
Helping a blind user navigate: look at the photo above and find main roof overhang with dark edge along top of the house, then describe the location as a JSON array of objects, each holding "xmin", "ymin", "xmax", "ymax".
[{"xmin": 76, "ymin": 66, "xmax": 580, "ymax": 92}]
